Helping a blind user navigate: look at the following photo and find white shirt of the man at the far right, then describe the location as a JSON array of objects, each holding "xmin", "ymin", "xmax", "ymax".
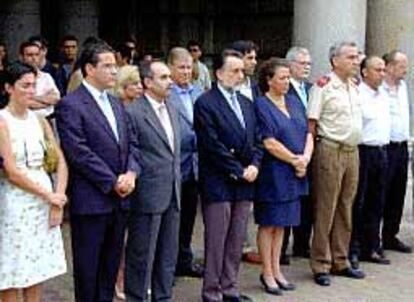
[{"xmin": 381, "ymin": 80, "xmax": 410, "ymax": 142}]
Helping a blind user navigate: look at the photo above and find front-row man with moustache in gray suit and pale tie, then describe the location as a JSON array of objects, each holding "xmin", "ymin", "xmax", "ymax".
[{"xmin": 125, "ymin": 61, "xmax": 181, "ymax": 302}]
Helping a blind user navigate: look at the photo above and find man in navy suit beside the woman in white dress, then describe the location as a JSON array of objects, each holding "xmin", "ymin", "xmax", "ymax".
[{"xmin": 56, "ymin": 43, "xmax": 139, "ymax": 302}]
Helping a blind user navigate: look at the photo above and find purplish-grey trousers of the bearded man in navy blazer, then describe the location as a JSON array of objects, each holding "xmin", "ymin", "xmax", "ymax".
[{"xmin": 202, "ymin": 201, "xmax": 251, "ymax": 302}]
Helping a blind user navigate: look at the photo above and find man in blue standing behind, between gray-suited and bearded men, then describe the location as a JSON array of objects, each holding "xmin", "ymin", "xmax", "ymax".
[{"xmin": 168, "ymin": 47, "xmax": 203, "ymax": 278}]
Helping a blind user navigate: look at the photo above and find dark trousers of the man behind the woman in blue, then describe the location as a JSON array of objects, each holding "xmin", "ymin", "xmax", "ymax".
[{"xmin": 281, "ymin": 196, "xmax": 313, "ymax": 256}]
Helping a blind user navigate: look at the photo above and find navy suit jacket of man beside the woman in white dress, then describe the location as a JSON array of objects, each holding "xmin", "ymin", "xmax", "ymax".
[{"xmin": 56, "ymin": 85, "xmax": 140, "ymax": 214}]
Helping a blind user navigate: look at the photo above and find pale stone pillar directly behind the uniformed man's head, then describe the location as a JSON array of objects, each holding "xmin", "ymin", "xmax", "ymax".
[{"xmin": 293, "ymin": 0, "xmax": 368, "ymax": 79}]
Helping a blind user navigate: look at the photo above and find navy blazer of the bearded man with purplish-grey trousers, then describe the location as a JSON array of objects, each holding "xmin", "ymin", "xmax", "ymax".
[{"xmin": 194, "ymin": 85, "xmax": 263, "ymax": 202}]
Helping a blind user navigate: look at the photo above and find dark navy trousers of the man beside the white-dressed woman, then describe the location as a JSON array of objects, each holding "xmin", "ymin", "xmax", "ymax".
[{"xmin": 70, "ymin": 210, "xmax": 128, "ymax": 302}]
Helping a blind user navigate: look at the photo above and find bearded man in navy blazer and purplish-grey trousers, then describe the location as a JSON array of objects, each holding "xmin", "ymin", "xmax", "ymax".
[{"xmin": 194, "ymin": 50, "xmax": 263, "ymax": 302}]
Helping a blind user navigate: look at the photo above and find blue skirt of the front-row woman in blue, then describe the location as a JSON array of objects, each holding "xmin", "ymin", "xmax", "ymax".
[{"xmin": 254, "ymin": 199, "xmax": 300, "ymax": 227}]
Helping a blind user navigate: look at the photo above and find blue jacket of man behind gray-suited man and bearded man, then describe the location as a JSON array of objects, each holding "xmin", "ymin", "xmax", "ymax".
[{"xmin": 167, "ymin": 84, "xmax": 204, "ymax": 181}]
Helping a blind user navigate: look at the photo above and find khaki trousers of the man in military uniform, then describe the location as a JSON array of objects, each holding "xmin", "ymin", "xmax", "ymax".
[{"xmin": 310, "ymin": 140, "xmax": 359, "ymax": 274}]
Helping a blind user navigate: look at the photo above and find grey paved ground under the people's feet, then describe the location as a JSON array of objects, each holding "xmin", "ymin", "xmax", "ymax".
[{"xmin": 36, "ymin": 172, "xmax": 414, "ymax": 302}]
